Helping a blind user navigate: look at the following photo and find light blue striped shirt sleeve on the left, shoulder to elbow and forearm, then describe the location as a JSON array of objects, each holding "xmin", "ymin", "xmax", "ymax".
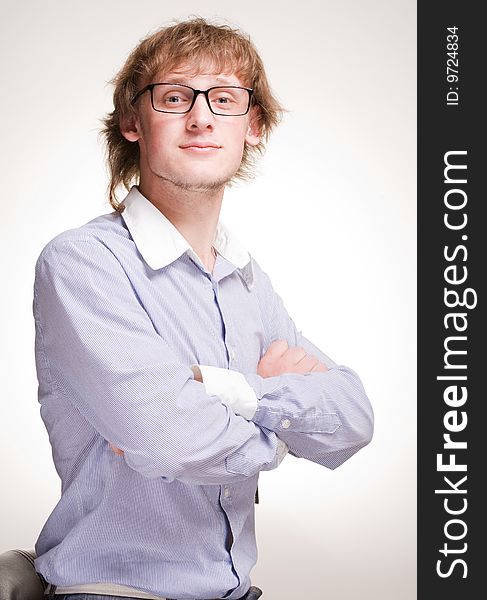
[{"xmin": 33, "ymin": 239, "xmax": 288, "ymax": 484}]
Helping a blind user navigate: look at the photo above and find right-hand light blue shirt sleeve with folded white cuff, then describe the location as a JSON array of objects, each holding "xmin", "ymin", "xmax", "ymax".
[{"xmin": 191, "ymin": 260, "xmax": 373, "ymax": 469}]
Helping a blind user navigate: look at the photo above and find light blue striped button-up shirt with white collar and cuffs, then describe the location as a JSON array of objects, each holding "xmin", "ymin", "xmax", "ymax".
[{"xmin": 33, "ymin": 187, "xmax": 373, "ymax": 599}]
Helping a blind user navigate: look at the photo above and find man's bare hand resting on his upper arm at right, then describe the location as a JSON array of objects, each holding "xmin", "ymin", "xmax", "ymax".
[{"xmin": 257, "ymin": 340, "xmax": 328, "ymax": 377}]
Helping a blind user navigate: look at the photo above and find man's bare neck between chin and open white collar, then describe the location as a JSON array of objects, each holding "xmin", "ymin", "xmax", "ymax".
[{"xmin": 138, "ymin": 181, "xmax": 224, "ymax": 272}]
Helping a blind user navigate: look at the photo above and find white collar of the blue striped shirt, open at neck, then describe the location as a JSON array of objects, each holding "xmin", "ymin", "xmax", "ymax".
[{"xmin": 122, "ymin": 186, "xmax": 253, "ymax": 289}]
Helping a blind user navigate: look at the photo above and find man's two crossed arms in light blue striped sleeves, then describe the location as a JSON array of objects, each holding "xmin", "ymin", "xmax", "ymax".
[{"xmin": 34, "ymin": 238, "xmax": 373, "ymax": 485}]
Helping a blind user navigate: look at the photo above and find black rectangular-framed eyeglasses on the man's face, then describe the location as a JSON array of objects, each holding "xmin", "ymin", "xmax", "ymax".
[{"xmin": 131, "ymin": 83, "xmax": 253, "ymax": 117}]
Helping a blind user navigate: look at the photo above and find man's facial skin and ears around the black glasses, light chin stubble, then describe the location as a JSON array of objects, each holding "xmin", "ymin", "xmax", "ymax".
[{"xmin": 122, "ymin": 69, "xmax": 260, "ymax": 191}]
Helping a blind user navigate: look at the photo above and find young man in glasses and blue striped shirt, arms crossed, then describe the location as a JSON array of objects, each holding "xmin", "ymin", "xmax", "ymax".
[{"xmin": 34, "ymin": 18, "xmax": 372, "ymax": 600}]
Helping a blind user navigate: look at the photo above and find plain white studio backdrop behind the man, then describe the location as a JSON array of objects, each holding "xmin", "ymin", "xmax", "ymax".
[{"xmin": 0, "ymin": 0, "xmax": 416, "ymax": 600}]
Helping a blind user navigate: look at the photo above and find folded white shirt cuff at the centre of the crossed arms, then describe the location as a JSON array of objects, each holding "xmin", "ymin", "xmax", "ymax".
[{"xmin": 191, "ymin": 365, "xmax": 257, "ymax": 421}]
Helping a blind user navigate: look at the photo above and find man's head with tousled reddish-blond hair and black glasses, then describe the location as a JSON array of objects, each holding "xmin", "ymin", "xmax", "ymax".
[{"xmin": 103, "ymin": 18, "xmax": 282, "ymax": 209}]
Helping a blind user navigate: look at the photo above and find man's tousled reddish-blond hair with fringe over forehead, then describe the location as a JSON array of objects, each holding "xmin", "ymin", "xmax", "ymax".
[{"xmin": 101, "ymin": 17, "xmax": 284, "ymax": 212}]
